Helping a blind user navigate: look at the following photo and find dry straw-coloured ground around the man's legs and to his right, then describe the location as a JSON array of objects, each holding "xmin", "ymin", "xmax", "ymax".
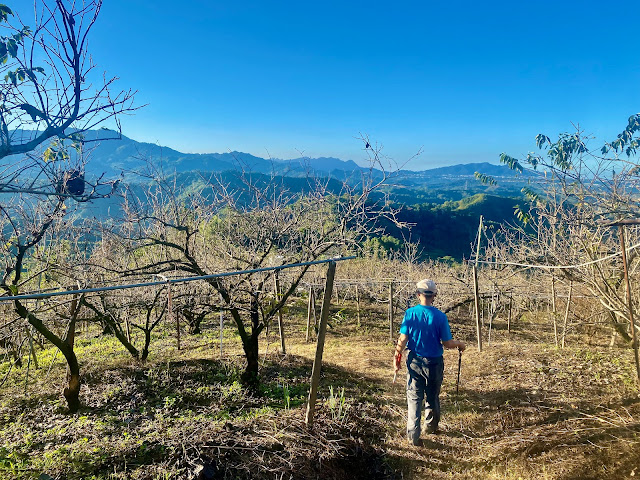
[{"xmin": 292, "ymin": 330, "xmax": 640, "ymax": 480}]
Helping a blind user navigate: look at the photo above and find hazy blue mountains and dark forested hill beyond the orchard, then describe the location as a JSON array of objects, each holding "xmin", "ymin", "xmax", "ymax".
[{"xmin": 6, "ymin": 130, "xmax": 528, "ymax": 260}]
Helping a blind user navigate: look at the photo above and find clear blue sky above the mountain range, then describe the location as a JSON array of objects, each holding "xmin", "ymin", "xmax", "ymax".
[{"xmin": 36, "ymin": 0, "xmax": 640, "ymax": 169}]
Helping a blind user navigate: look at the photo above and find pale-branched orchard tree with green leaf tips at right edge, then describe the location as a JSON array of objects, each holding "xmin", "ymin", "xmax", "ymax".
[{"xmin": 476, "ymin": 114, "xmax": 640, "ymax": 348}]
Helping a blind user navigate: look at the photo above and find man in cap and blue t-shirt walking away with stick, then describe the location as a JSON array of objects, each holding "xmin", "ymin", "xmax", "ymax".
[{"xmin": 393, "ymin": 279, "xmax": 466, "ymax": 445}]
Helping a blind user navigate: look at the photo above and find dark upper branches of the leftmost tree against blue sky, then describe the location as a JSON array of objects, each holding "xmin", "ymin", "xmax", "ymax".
[{"xmin": 0, "ymin": 0, "xmax": 135, "ymax": 161}]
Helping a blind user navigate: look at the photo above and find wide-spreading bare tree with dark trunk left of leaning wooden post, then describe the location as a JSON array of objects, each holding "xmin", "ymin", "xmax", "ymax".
[{"xmin": 105, "ymin": 141, "xmax": 404, "ymax": 387}]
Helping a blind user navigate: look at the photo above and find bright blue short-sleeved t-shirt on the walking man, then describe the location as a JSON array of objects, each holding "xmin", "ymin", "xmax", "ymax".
[{"xmin": 400, "ymin": 304, "xmax": 452, "ymax": 357}]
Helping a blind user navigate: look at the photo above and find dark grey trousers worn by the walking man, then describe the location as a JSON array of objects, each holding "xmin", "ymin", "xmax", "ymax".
[{"xmin": 407, "ymin": 351, "xmax": 444, "ymax": 444}]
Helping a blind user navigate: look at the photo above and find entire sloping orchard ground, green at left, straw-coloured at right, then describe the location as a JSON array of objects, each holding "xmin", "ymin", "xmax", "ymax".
[{"xmin": 0, "ymin": 302, "xmax": 640, "ymax": 480}]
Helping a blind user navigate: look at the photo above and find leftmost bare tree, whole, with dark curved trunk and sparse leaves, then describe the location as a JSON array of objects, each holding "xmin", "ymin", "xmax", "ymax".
[{"xmin": 0, "ymin": 0, "xmax": 135, "ymax": 411}]
